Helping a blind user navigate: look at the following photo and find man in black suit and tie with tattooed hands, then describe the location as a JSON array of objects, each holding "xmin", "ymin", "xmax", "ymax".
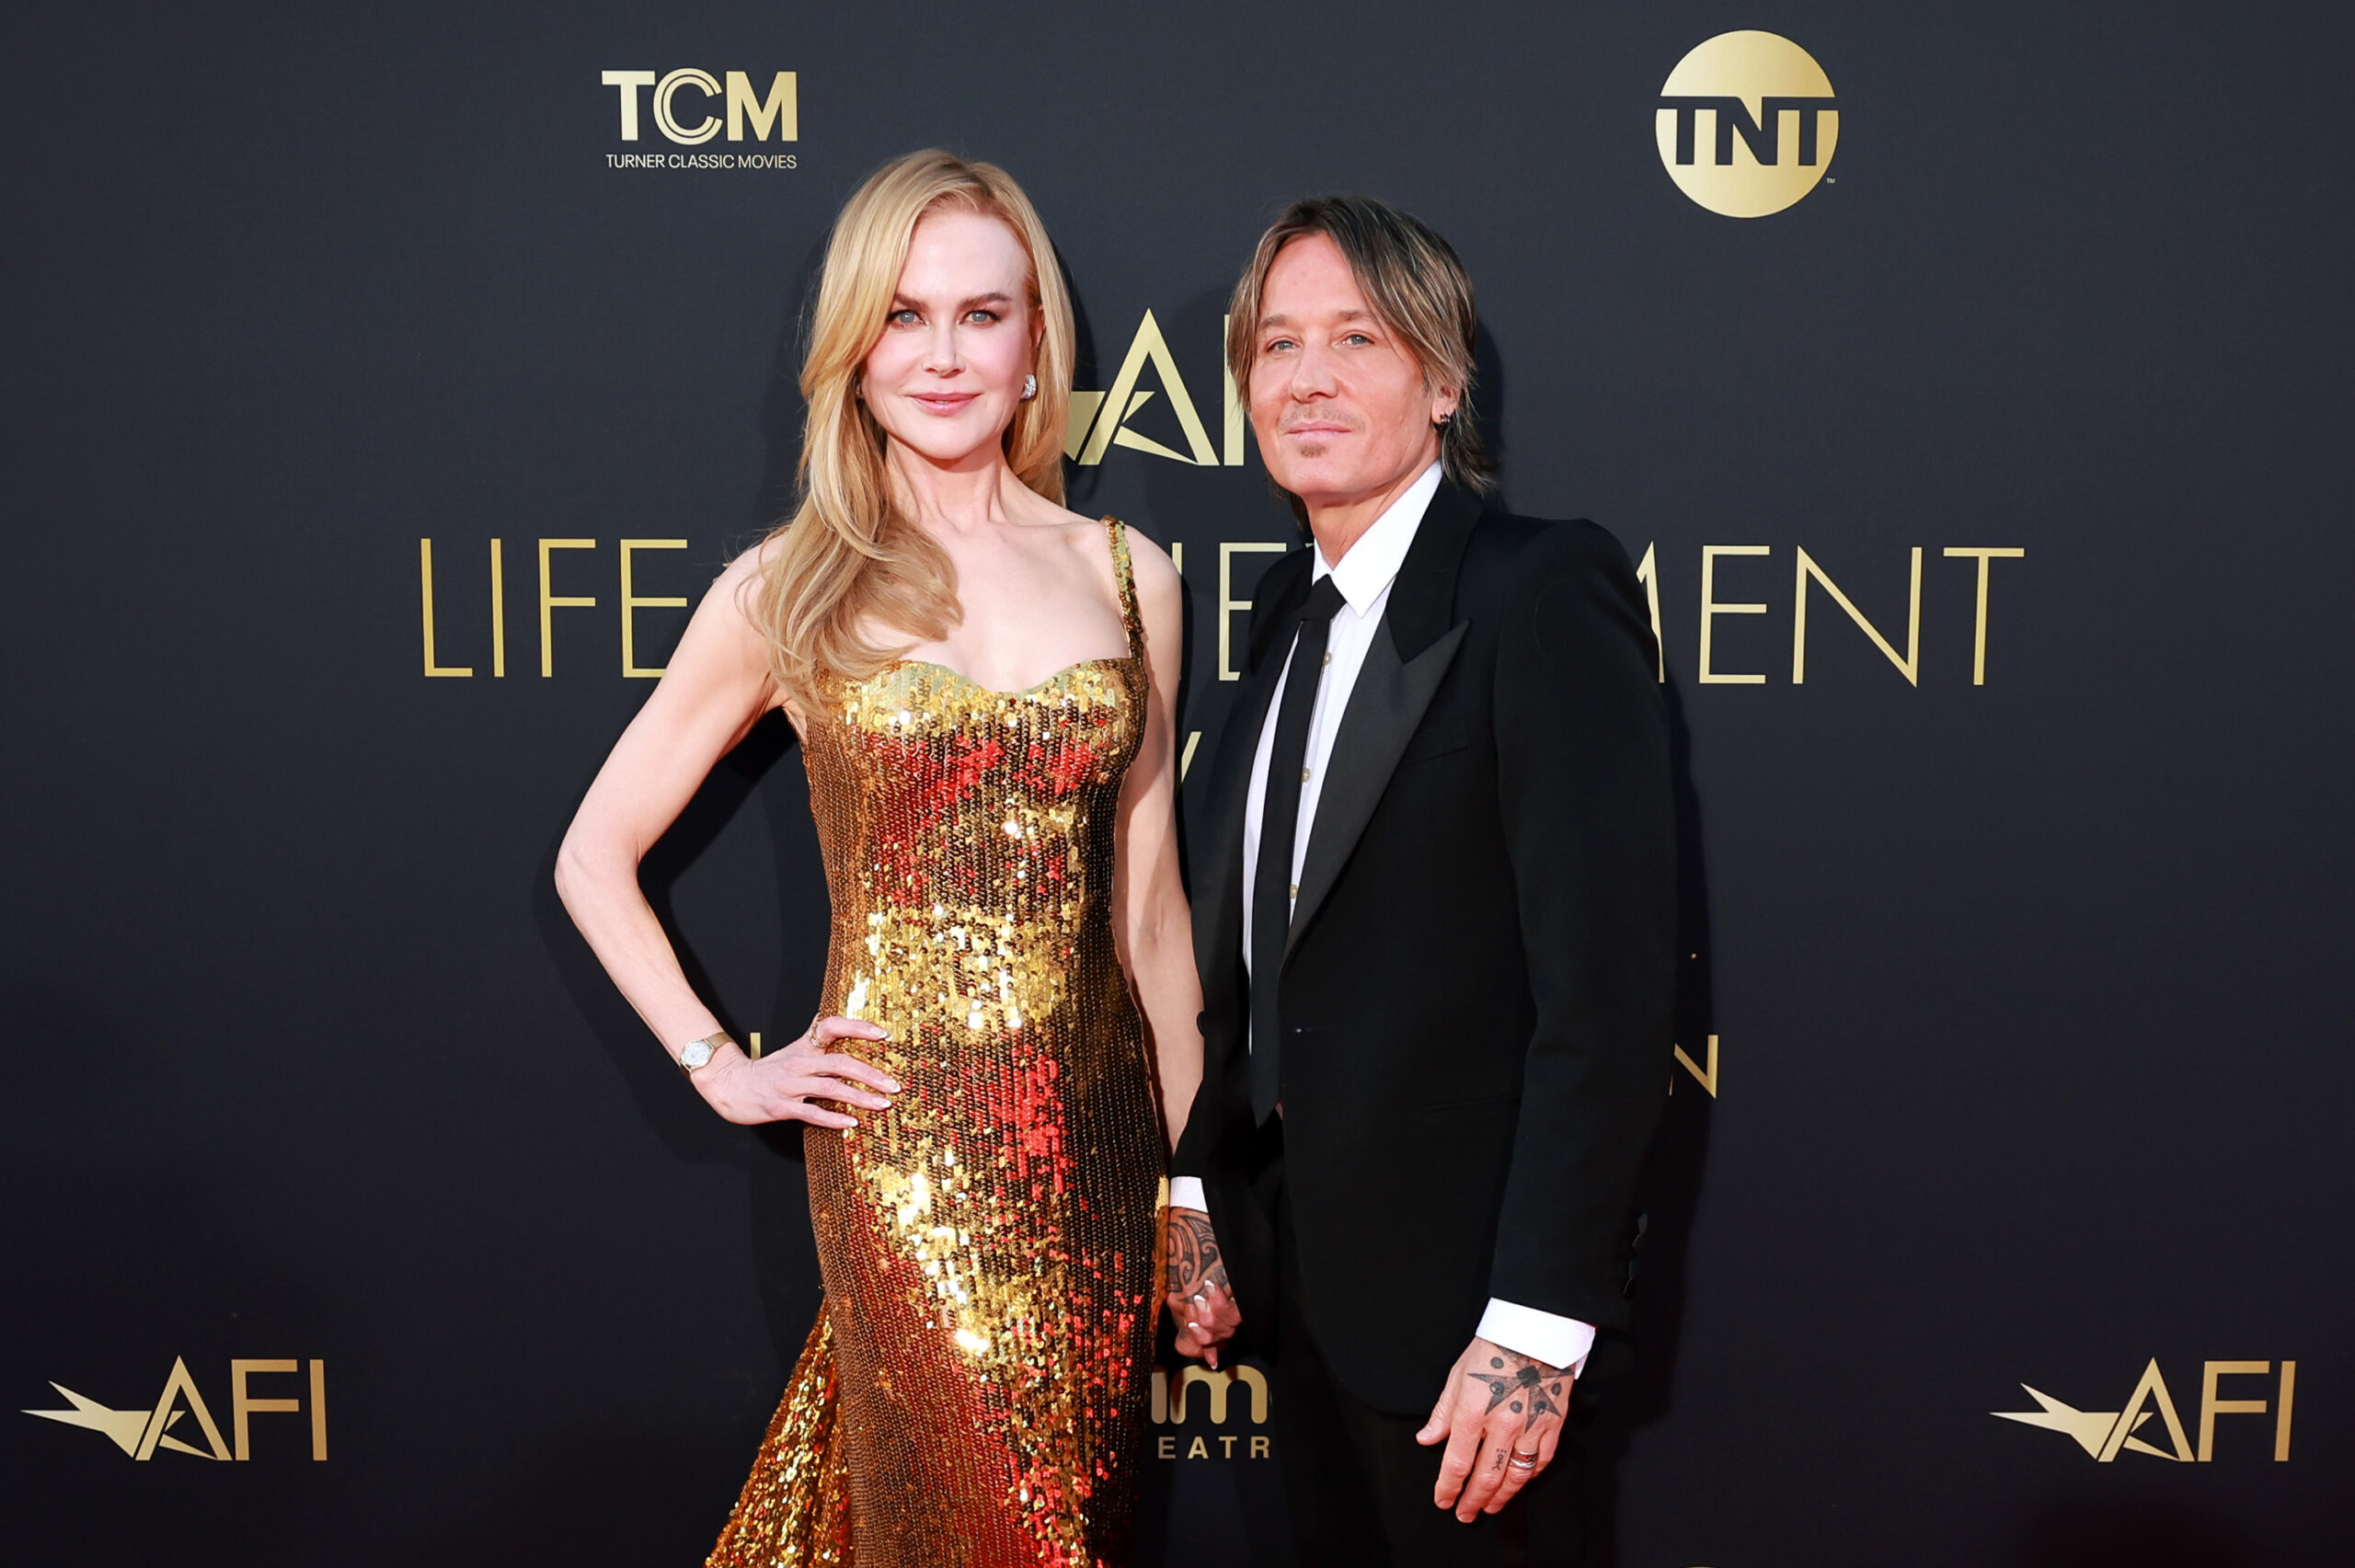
[{"xmin": 1170, "ymin": 198, "xmax": 1677, "ymax": 1568}]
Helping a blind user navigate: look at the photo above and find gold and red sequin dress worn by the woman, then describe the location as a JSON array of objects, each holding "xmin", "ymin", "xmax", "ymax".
[{"xmin": 711, "ymin": 518, "xmax": 1164, "ymax": 1568}]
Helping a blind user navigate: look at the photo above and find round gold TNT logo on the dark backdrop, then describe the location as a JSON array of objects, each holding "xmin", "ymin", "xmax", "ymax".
[{"xmin": 1653, "ymin": 33, "xmax": 1839, "ymax": 217}]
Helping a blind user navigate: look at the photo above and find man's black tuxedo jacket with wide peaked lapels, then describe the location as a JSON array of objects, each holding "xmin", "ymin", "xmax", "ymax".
[{"xmin": 1173, "ymin": 485, "xmax": 1677, "ymax": 1415}]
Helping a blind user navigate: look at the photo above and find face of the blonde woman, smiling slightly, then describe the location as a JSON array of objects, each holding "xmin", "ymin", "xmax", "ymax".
[{"xmin": 859, "ymin": 207, "xmax": 1039, "ymax": 468}]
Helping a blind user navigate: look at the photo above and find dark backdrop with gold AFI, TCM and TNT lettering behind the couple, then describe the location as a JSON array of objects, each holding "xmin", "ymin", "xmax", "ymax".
[{"xmin": 0, "ymin": 0, "xmax": 2355, "ymax": 1568}]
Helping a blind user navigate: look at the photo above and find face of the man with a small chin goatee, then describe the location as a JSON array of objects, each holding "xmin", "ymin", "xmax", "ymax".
[{"xmin": 1248, "ymin": 233, "xmax": 1455, "ymax": 516}]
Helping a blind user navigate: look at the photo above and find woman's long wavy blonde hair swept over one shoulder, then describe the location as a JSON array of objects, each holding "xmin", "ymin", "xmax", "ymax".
[{"xmin": 753, "ymin": 148, "xmax": 1074, "ymax": 706}]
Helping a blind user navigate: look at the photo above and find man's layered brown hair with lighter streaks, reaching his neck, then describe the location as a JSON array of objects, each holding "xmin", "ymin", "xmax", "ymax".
[{"xmin": 1227, "ymin": 195, "xmax": 1496, "ymax": 495}]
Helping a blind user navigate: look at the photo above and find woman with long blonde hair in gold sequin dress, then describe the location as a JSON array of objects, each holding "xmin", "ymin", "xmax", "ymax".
[{"xmin": 558, "ymin": 151, "xmax": 1201, "ymax": 1568}]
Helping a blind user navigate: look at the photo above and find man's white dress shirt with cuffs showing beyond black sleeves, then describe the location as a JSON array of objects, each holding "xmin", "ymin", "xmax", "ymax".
[{"xmin": 1170, "ymin": 464, "xmax": 1594, "ymax": 1378}]
